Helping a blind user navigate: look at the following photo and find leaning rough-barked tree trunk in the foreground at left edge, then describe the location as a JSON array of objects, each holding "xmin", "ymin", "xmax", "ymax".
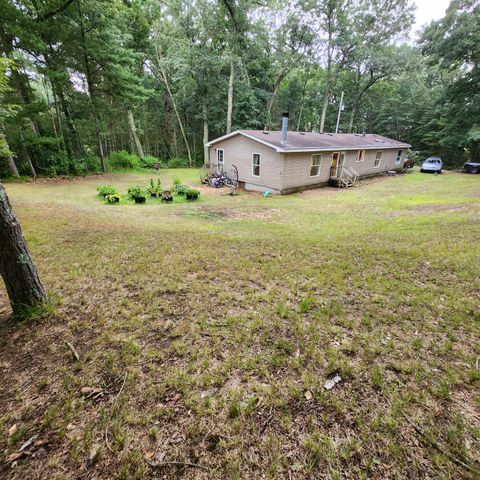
[{"xmin": 0, "ymin": 183, "xmax": 47, "ymax": 314}]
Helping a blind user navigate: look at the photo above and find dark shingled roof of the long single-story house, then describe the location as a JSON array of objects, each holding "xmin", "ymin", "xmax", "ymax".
[{"xmin": 239, "ymin": 130, "xmax": 410, "ymax": 151}]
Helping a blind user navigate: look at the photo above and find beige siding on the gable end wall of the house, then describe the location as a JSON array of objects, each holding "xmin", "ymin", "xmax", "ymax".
[{"xmin": 210, "ymin": 135, "xmax": 283, "ymax": 190}]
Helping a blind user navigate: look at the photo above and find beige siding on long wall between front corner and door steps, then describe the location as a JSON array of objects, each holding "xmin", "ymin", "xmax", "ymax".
[{"xmin": 283, "ymin": 152, "xmax": 332, "ymax": 189}]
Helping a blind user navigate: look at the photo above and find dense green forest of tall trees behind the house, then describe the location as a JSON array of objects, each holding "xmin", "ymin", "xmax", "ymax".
[{"xmin": 0, "ymin": 0, "xmax": 480, "ymax": 176}]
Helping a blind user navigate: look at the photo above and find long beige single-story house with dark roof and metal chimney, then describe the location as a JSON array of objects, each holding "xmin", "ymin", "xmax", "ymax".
[{"xmin": 206, "ymin": 114, "xmax": 410, "ymax": 194}]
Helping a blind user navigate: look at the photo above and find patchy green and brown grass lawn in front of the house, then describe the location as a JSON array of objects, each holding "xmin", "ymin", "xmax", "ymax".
[{"xmin": 0, "ymin": 169, "xmax": 480, "ymax": 480}]
